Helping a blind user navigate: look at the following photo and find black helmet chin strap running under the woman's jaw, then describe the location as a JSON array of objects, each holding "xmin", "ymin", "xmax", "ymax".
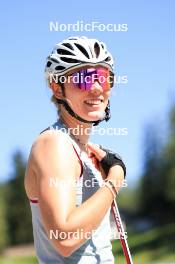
[{"xmin": 57, "ymin": 98, "xmax": 110, "ymax": 126}]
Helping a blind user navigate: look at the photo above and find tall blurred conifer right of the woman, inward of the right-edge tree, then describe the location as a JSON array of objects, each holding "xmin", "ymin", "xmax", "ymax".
[{"xmin": 139, "ymin": 123, "xmax": 167, "ymax": 222}]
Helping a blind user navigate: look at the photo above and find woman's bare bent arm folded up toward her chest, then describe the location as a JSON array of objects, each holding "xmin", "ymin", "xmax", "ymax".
[{"xmin": 32, "ymin": 131, "xmax": 123, "ymax": 256}]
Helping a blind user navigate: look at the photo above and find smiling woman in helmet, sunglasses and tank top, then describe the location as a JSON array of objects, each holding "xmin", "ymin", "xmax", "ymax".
[{"xmin": 25, "ymin": 37, "xmax": 125, "ymax": 264}]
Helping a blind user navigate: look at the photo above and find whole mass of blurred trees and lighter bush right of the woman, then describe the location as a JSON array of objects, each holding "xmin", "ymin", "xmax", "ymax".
[{"xmin": 118, "ymin": 106, "xmax": 175, "ymax": 225}]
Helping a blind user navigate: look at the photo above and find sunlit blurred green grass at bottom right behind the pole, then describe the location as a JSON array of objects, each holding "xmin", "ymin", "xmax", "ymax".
[{"xmin": 113, "ymin": 224, "xmax": 175, "ymax": 264}]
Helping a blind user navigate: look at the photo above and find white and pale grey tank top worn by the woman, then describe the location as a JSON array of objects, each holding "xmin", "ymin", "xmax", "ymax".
[{"xmin": 30, "ymin": 119, "xmax": 116, "ymax": 264}]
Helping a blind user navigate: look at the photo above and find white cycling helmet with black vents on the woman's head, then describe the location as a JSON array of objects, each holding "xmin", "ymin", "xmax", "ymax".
[{"xmin": 45, "ymin": 37, "xmax": 114, "ymax": 79}]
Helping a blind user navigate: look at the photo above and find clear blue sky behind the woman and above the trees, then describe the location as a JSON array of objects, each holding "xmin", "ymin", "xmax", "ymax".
[{"xmin": 0, "ymin": 0, "xmax": 175, "ymax": 184}]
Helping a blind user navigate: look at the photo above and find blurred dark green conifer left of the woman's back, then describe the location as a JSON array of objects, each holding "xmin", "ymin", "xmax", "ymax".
[{"xmin": 6, "ymin": 151, "xmax": 33, "ymax": 245}]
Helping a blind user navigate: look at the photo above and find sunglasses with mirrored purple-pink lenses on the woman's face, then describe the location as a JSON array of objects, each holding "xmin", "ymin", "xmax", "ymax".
[{"xmin": 71, "ymin": 68, "xmax": 114, "ymax": 91}]
